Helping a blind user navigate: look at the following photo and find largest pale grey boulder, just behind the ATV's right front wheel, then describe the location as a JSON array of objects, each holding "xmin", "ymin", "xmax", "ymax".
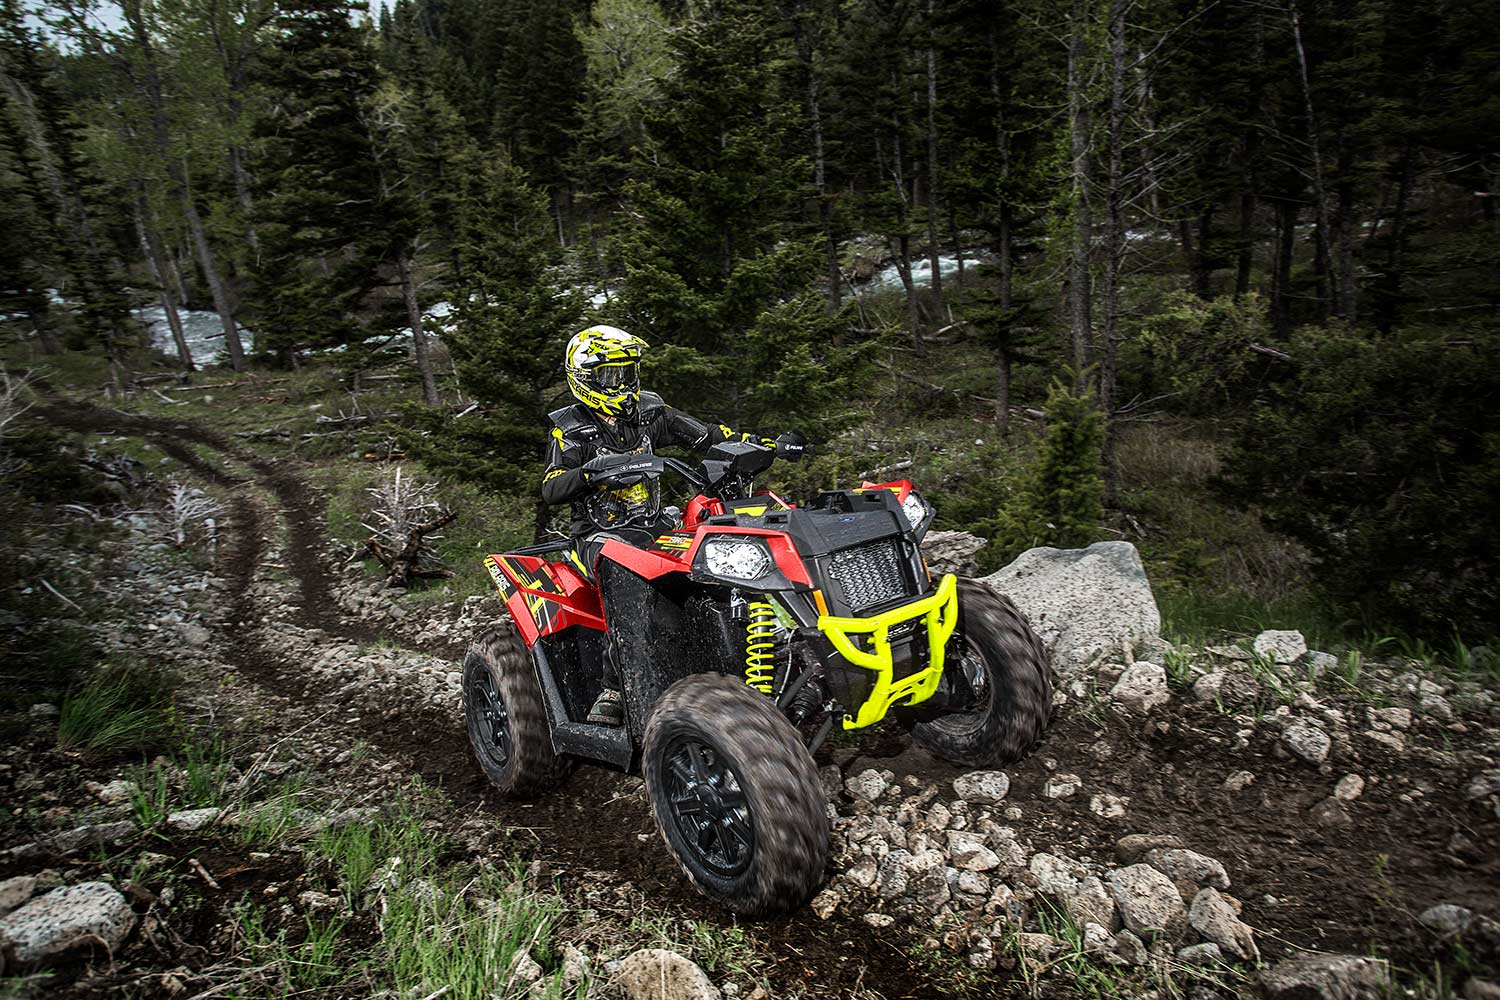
[{"xmin": 984, "ymin": 541, "xmax": 1161, "ymax": 676}]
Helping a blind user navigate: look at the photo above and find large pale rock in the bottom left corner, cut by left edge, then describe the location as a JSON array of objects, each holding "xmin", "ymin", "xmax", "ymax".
[{"xmin": 0, "ymin": 882, "xmax": 135, "ymax": 966}]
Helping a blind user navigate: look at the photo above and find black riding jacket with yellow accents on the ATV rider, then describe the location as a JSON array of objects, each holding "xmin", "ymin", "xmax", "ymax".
[{"xmin": 542, "ymin": 393, "xmax": 761, "ymax": 537}]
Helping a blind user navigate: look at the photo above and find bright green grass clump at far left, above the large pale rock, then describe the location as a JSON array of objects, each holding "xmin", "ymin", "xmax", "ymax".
[{"xmin": 57, "ymin": 664, "xmax": 174, "ymax": 756}]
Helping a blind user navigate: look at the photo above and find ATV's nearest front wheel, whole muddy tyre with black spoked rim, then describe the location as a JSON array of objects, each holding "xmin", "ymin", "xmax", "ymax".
[{"xmin": 642, "ymin": 673, "xmax": 828, "ymax": 916}]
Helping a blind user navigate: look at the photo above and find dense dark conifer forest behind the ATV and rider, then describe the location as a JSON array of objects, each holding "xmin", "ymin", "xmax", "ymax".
[{"xmin": 0, "ymin": 0, "xmax": 1500, "ymax": 658}]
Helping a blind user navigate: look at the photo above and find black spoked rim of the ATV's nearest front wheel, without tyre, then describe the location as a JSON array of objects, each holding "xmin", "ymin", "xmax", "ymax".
[{"xmin": 666, "ymin": 736, "xmax": 755, "ymax": 879}]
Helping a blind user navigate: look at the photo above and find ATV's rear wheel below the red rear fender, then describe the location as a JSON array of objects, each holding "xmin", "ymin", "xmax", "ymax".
[{"xmin": 464, "ymin": 630, "xmax": 573, "ymax": 798}]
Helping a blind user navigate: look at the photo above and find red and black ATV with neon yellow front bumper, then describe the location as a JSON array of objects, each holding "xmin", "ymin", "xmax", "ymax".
[{"xmin": 464, "ymin": 435, "xmax": 1052, "ymax": 916}]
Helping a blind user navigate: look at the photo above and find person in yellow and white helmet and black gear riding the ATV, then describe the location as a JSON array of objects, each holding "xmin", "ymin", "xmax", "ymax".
[{"xmin": 542, "ymin": 327, "xmax": 776, "ymax": 726}]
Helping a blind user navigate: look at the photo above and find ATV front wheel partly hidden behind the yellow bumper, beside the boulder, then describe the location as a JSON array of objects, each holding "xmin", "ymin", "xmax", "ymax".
[{"xmin": 912, "ymin": 579, "xmax": 1052, "ymax": 768}]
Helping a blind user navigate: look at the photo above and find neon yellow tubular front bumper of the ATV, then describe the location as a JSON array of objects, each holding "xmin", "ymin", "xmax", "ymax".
[{"xmin": 818, "ymin": 573, "xmax": 959, "ymax": 729}]
